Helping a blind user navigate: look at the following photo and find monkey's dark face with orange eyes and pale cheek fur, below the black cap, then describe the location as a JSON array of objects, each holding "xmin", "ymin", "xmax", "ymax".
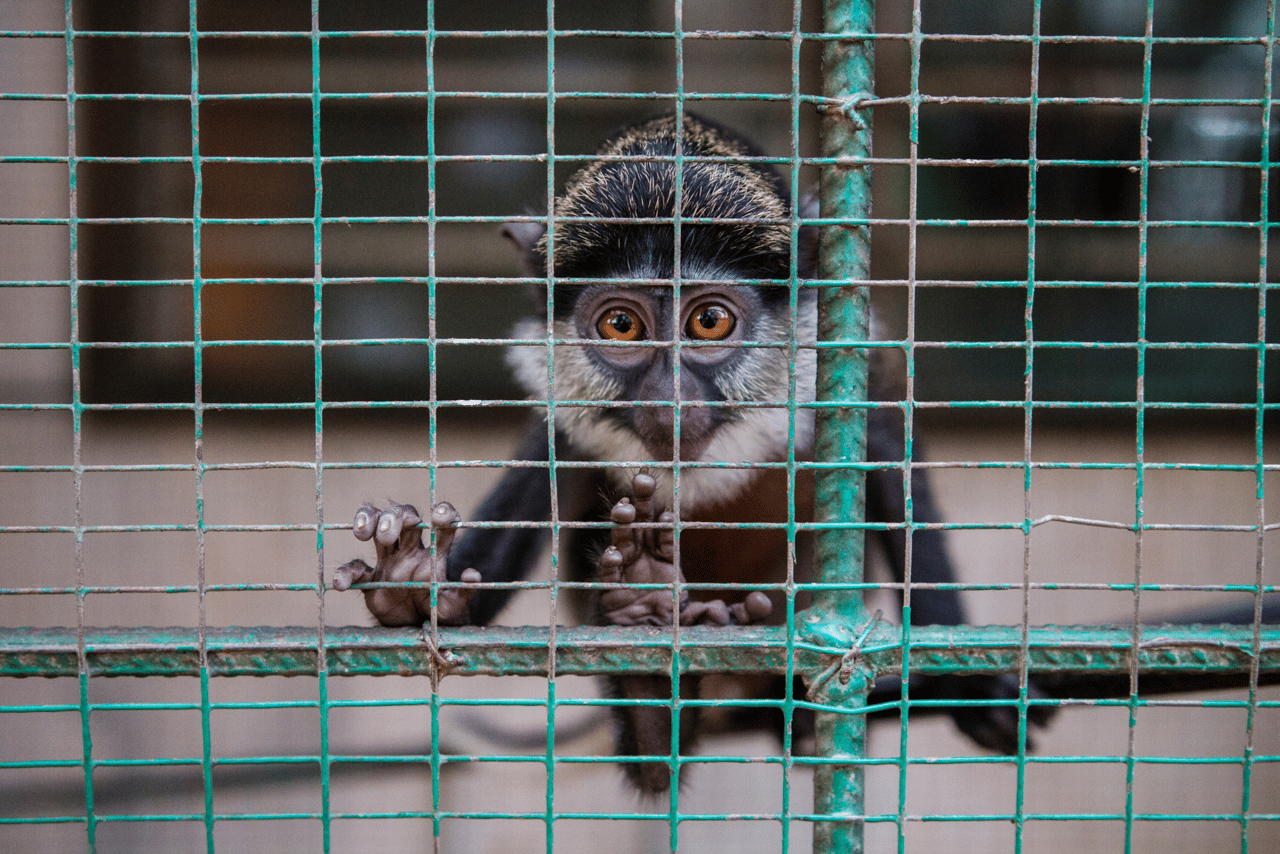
[{"xmin": 509, "ymin": 282, "xmax": 815, "ymax": 507}]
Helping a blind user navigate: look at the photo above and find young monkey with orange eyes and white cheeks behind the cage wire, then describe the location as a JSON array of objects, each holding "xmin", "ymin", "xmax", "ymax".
[{"xmin": 333, "ymin": 111, "xmax": 1048, "ymax": 795}]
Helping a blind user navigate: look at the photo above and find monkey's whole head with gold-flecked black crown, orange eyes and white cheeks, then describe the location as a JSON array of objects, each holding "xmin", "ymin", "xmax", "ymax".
[{"xmin": 507, "ymin": 114, "xmax": 815, "ymax": 504}]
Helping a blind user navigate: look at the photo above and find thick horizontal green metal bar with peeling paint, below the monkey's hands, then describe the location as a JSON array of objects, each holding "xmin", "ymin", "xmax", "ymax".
[{"xmin": 0, "ymin": 625, "xmax": 1280, "ymax": 677}]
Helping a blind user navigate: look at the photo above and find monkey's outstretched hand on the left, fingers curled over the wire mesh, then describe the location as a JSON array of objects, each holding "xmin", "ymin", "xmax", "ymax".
[{"xmin": 333, "ymin": 501, "xmax": 481, "ymax": 626}]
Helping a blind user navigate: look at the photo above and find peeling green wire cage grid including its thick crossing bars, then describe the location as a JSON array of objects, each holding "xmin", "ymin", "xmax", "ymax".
[{"xmin": 0, "ymin": 1, "xmax": 1280, "ymax": 850}]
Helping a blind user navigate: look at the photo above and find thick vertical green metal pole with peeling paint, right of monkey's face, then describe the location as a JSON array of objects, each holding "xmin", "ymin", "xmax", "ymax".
[{"xmin": 805, "ymin": 0, "xmax": 874, "ymax": 853}]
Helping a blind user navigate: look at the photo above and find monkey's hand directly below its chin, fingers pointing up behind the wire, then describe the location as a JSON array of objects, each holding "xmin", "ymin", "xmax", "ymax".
[{"xmin": 598, "ymin": 471, "xmax": 773, "ymax": 626}]
